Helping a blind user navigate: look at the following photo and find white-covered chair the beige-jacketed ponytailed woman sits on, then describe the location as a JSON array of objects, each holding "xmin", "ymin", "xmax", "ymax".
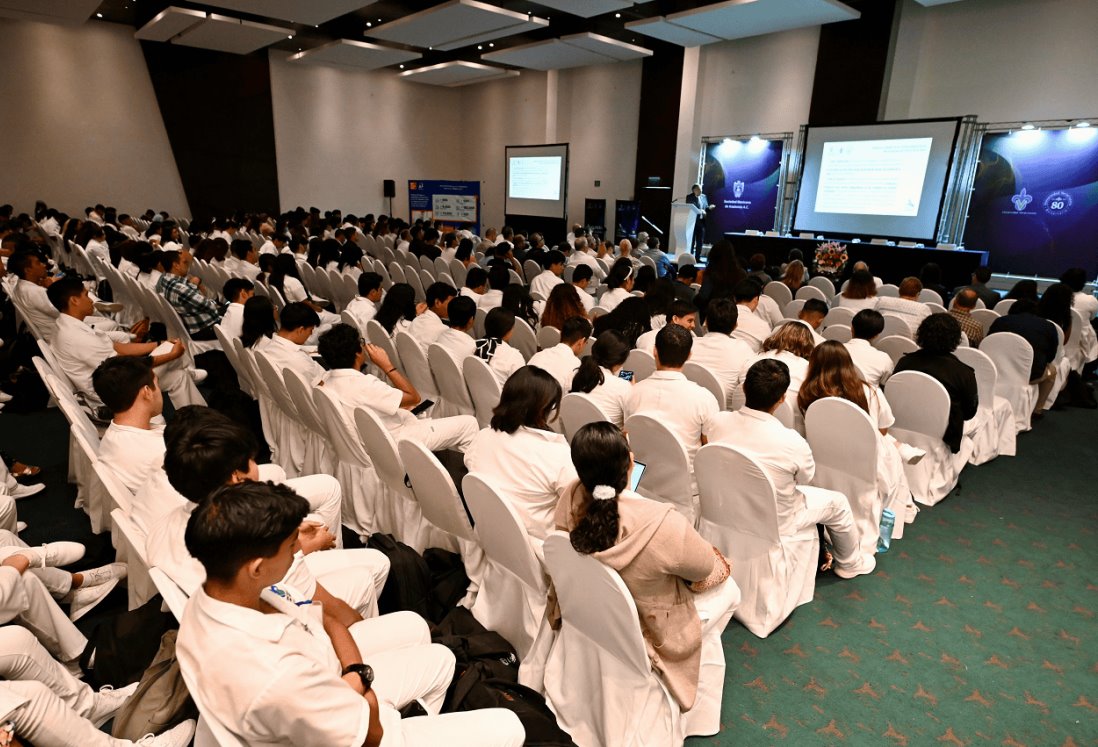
[{"xmin": 545, "ymin": 533, "xmax": 686, "ymax": 747}]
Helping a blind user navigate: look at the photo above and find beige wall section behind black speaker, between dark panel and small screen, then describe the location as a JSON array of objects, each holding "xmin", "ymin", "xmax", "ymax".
[{"xmin": 270, "ymin": 51, "xmax": 467, "ymax": 219}]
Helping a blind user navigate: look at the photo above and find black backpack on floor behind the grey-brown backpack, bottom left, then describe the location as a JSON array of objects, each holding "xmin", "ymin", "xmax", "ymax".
[{"xmin": 80, "ymin": 594, "xmax": 178, "ymax": 689}]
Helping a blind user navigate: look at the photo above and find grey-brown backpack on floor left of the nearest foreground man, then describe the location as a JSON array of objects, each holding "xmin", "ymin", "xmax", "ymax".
[{"xmin": 111, "ymin": 631, "xmax": 199, "ymax": 740}]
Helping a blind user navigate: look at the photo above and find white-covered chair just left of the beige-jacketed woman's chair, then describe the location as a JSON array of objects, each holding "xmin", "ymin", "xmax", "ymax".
[{"xmin": 461, "ymin": 473, "xmax": 551, "ymax": 667}]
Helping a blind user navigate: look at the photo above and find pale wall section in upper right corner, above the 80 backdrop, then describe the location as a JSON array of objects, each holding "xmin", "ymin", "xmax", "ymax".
[{"xmin": 885, "ymin": 0, "xmax": 1098, "ymax": 122}]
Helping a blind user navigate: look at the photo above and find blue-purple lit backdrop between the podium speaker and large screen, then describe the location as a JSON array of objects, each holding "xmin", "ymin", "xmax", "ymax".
[{"xmin": 702, "ymin": 138, "xmax": 784, "ymax": 235}]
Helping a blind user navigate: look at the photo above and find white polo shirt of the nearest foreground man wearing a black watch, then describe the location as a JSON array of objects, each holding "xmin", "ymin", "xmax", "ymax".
[{"xmin": 176, "ymin": 589, "xmax": 373, "ymax": 746}]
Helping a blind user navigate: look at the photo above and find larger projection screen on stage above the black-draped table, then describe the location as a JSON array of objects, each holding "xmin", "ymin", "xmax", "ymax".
[{"xmin": 793, "ymin": 118, "xmax": 961, "ymax": 241}]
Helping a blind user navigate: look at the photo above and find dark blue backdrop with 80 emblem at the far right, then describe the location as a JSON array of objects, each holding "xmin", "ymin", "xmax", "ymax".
[{"xmin": 964, "ymin": 127, "xmax": 1098, "ymax": 278}]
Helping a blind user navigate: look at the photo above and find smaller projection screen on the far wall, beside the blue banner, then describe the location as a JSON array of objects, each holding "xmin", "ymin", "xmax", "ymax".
[{"xmin": 504, "ymin": 143, "xmax": 568, "ymax": 219}]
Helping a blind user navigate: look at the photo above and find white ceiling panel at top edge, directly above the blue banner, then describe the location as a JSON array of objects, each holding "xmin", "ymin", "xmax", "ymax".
[{"xmin": 366, "ymin": 0, "xmax": 549, "ymax": 49}]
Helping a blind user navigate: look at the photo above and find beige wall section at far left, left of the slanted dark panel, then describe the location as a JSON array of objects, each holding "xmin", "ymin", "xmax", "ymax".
[{"xmin": 0, "ymin": 20, "xmax": 190, "ymax": 216}]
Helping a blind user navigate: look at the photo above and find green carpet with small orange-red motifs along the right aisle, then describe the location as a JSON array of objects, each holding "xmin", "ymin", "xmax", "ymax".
[{"xmin": 688, "ymin": 410, "xmax": 1098, "ymax": 747}]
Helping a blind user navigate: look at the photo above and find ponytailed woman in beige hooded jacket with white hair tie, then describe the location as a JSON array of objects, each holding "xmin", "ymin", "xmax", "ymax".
[{"xmin": 557, "ymin": 422, "xmax": 740, "ymax": 716}]
